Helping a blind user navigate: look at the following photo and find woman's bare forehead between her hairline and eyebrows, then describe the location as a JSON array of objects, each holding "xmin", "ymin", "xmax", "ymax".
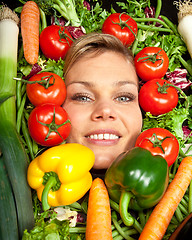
[{"xmin": 66, "ymin": 51, "xmax": 138, "ymax": 86}]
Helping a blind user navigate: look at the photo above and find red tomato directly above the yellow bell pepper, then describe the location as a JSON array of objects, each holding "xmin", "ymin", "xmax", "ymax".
[{"xmin": 28, "ymin": 104, "xmax": 71, "ymax": 146}]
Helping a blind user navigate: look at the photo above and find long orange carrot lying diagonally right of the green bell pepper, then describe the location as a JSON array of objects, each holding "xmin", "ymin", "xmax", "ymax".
[{"xmin": 139, "ymin": 156, "xmax": 192, "ymax": 240}]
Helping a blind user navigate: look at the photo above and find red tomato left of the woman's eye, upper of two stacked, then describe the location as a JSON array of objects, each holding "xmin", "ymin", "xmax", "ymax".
[{"xmin": 26, "ymin": 72, "xmax": 66, "ymax": 106}]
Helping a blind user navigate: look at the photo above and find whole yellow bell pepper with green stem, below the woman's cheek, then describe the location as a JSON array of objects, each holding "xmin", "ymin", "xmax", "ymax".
[{"xmin": 27, "ymin": 143, "xmax": 95, "ymax": 210}]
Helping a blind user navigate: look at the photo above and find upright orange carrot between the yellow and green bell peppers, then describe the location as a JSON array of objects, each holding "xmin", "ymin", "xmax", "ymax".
[{"xmin": 86, "ymin": 178, "xmax": 113, "ymax": 240}]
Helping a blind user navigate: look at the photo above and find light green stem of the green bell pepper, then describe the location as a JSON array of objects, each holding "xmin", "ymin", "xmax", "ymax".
[{"xmin": 119, "ymin": 191, "xmax": 134, "ymax": 226}]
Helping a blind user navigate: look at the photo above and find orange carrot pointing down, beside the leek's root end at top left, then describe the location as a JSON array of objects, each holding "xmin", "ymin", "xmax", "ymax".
[{"xmin": 21, "ymin": 1, "xmax": 40, "ymax": 64}]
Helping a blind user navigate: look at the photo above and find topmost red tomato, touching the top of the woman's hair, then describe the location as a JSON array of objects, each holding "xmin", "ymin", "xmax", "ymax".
[{"xmin": 102, "ymin": 13, "xmax": 137, "ymax": 46}]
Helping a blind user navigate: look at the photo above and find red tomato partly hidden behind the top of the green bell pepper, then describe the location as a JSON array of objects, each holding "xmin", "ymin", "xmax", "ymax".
[{"xmin": 135, "ymin": 128, "xmax": 179, "ymax": 166}]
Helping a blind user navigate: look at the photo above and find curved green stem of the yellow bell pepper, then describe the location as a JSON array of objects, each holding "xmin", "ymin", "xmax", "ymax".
[{"xmin": 41, "ymin": 176, "xmax": 57, "ymax": 211}]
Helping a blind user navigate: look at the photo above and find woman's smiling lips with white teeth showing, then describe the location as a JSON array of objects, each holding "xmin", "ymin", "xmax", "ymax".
[{"xmin": 85, "ymin": 129, "xmax": 121, "ymax": 146}]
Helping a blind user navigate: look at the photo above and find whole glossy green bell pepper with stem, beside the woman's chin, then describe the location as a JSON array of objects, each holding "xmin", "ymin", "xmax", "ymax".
[{"xmin": 105, "ymin": 147, "xmax": 169, "ymax": 226}]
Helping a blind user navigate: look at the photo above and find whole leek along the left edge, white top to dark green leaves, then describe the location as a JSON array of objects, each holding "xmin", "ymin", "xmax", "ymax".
[{"xmin": 0, "ymin": 6, "xmax": 34, "ymax": 240}]
